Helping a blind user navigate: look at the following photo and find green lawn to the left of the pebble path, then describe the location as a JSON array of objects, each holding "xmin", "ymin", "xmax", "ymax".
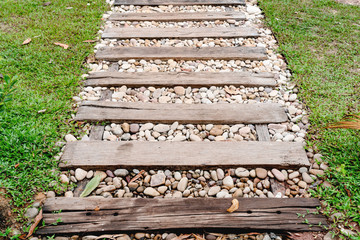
[{"xmin": 0, "ymin": 0, "xmax": 107, "ymax": 216}]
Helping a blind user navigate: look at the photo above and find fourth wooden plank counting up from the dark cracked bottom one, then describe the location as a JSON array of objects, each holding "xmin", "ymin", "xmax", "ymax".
[{"xmin": 85, "ymin": 72, "xmax": 276, "ymax": 87}]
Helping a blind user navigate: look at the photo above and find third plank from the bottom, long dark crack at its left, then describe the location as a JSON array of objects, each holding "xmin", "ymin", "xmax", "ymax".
[{"xmin": 75, "ymin": 101, "xmax": 288, "ymax": 124}]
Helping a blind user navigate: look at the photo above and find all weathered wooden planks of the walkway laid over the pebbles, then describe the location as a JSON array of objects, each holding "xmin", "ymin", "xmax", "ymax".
[{"xmin": 37, "ymin": 0, "xmax": 326, "ymax": 235}]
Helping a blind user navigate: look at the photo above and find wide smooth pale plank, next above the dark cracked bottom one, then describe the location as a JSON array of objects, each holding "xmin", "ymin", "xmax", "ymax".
[{"xmin": 60, "ymin": 141, "xmax": 310, "ymax": 170}]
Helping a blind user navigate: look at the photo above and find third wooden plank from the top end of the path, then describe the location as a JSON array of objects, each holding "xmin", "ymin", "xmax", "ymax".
[{"xmin": 102, "ymin": 27, "xmax": 260, "ymax": 39}]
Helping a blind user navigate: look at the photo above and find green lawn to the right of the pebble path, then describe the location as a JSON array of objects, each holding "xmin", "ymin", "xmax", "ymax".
[{"xmin": 260, "ymin": 0, "xmax": 360, "ymax": 239}]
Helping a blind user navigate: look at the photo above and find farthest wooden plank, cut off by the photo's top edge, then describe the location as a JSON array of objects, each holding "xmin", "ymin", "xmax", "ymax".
[{"xmin": 114, "ymin": 0, "xmax": 245, "ymax": 6}]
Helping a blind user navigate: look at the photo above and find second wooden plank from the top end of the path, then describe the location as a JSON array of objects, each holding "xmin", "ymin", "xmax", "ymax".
[{"xmin": 108, "ymin": 12, "xmax": 246, "ymax": 22}]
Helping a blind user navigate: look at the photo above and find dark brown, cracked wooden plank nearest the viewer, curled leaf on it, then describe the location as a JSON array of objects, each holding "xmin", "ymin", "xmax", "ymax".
[{"xmin": 36, "ymin": 197, "xmax": 327, "ymax": 235}]
